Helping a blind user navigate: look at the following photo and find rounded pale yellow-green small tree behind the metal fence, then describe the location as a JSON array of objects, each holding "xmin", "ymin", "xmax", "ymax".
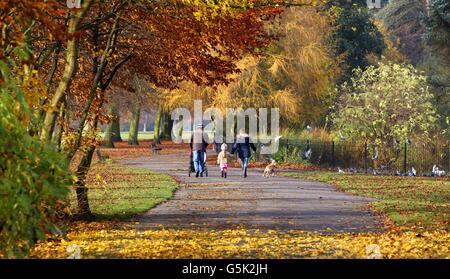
[{"xmin": 334, "ymin": 63, "xmax": 438, "ymax": 165}]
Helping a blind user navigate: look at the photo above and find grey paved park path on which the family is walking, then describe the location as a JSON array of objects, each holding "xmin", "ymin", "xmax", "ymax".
[{"xmin": 122, "ymin": 154, "xmax": 383, "ymax": 232}]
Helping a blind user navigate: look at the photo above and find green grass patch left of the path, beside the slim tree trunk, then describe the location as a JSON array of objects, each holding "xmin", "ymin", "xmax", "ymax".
[{"xmin": 70, "ymin": 162, "xmax": 178, "ymax": 218}]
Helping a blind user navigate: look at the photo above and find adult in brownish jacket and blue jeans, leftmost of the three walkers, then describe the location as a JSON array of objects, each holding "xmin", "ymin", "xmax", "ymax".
[{"xmin": 190, "ymin": 125, "xmax": 208, "ymax": 177}]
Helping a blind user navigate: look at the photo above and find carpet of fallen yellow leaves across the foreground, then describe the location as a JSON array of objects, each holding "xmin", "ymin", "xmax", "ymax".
[{"xmin": 32, "ymin": 222, "xmax": 450, "ymax": 259}]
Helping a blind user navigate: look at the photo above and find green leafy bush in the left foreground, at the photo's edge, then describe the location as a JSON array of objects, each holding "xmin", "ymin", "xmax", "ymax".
[{"xmin": 0, "ymin": 63, "xmax": 70, "ymax": 258}]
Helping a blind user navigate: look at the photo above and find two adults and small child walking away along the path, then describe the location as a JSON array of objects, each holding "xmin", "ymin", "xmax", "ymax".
[{"xmin": 190, "ymin": 125, "xmax": 256, "ymax": 178}]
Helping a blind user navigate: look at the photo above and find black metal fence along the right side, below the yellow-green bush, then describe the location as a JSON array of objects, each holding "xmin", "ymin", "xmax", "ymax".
[{"xmin": 255, "ymin": 139, "xmax": 450, "ymax": 175}]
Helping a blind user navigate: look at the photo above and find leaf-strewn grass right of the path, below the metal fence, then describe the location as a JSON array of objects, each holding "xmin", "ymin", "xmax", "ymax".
[{"xmin": 285, "ymin": 171, "xmax": 450, "ymax": 231}]
